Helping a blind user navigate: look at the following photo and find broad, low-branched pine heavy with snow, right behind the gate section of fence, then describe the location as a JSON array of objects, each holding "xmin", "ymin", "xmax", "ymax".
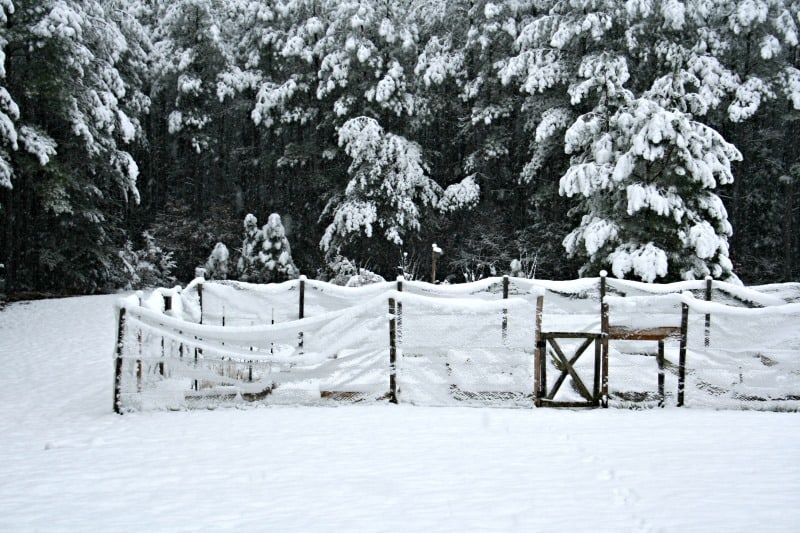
[{"xmin": 560, "ymin": 85, "xmax": 741, "ymax": 282}]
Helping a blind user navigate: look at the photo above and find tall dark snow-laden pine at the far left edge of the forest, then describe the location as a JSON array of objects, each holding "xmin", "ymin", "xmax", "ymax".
[{"xmin": 0, "ymin": 0, "xmax": 146, "ymax": 291}]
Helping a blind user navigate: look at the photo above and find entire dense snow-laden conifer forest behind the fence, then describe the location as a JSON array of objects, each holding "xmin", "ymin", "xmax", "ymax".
[{"xmin": 0, "ymin": 0, "xmax": 800, "ymax": 293}]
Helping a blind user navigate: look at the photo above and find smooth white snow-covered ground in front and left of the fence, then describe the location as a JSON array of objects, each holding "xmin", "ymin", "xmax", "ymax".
[{"xmin": 0, "ymin": 296, "xmax": 800, "ymax": 531}]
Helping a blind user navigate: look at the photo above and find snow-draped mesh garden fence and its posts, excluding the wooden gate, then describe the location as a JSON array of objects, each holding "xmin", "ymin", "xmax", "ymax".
[{"xmin": 114, "ymin": 277, "xmax": 800, "ymax": 412}]
